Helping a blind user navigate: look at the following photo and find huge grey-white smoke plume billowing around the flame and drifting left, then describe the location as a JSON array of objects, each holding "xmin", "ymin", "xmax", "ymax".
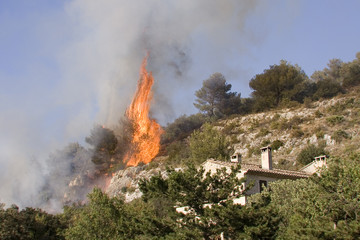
[{"xmin": 0, "ymin": 0, "xmax": 298, "ymax": 210}]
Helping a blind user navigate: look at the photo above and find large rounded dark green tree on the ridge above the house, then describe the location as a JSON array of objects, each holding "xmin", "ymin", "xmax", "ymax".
[{"xmin": 249, "ymin": 60, "xmax": 307, "ymax": 111}]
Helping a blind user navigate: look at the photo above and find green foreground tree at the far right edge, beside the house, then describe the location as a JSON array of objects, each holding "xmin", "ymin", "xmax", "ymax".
[{"xmin": 312, "ymin": 154, "xmax": 360, "ymax": 239}]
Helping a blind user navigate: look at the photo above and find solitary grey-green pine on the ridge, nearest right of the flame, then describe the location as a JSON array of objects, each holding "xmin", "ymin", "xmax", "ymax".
[{"xmin": 194, "ymin": 73, "xmax": 241, "ymax": 117}]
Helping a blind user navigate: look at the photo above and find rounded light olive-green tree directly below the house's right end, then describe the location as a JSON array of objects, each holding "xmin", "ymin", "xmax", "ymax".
[{"xmin": 261, "ymin": 179, "xmax": 334, "ymax": 239}]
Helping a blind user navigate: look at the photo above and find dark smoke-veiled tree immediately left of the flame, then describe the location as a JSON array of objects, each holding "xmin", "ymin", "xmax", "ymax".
[{"xmin": 85, "ymin": 125, "xmax": 118, "ymax": 164}]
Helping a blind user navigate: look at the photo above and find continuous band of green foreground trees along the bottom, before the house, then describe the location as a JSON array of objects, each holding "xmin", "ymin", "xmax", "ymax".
[{"xmin": 0, "ymin": 155, "xmax": 360, "ymax": 239}]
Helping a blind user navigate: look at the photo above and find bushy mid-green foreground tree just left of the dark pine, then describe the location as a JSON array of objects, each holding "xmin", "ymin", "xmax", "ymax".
[{"xmin": 64, "ymin": 188, "xmax": 175, "ymax": 239}]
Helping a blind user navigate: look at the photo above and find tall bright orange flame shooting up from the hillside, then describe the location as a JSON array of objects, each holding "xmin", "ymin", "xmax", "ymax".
[{"xmin": 124, "ymin": 57, "xmax": 163, "ymax": 166}]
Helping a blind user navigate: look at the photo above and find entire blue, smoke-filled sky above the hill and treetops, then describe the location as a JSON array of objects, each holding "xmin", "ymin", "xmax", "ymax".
[{"xmin": 0, "ymin": 0, "xmax": 360, "ymax": 206}]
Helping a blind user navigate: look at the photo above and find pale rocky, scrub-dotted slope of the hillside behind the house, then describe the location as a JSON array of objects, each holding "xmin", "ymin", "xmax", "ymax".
[{"xmin": 107, "ymin": 88, "xmax": 360, "ymax": 201}]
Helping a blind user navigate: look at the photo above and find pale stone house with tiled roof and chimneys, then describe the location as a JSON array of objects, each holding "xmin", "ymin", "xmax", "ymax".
[{"xmin": 202, "ymin": 146, "xmax": 320, "ymax": 205}]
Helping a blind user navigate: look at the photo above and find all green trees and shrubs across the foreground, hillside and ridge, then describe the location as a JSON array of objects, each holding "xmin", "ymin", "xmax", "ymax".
[{"xmin": 0, "ymin": 53, "xmax": 360, "ymax": 239}]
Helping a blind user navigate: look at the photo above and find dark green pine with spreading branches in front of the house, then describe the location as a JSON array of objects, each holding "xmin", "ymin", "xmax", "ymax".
[{"xmin": 140, "ymin": 165, "xmax": 280, "ymax": 239}]
